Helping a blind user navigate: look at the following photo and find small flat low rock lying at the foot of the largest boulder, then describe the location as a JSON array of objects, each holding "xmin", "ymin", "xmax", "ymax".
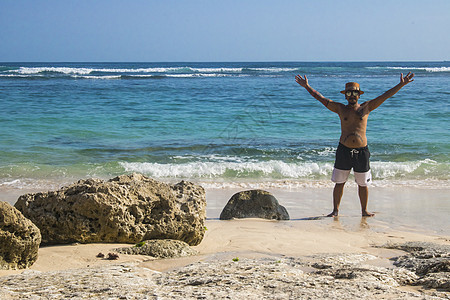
[{"xmin": 114, "ymin": 240, "xmax": 197, "ymax": 258}]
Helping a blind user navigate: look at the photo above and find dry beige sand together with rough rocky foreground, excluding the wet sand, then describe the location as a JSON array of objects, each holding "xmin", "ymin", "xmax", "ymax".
[{"xmin": 0, "ymin": 219, "xmax": 450, "ymax": 299}]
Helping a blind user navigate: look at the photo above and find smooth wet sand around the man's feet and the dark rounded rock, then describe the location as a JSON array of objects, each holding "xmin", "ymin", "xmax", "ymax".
[{"xmin": 206, "ymin": 184, "xmax": 450, "ymax": 236}]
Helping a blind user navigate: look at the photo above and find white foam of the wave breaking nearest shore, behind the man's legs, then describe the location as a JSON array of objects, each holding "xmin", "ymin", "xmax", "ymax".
[{"xmin": 120, "ymin": 159, "xmax": 448, "ymax": 180}]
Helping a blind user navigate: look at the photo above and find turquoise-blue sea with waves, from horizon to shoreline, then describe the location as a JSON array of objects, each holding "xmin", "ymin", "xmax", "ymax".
[{"xmin": 0, "ymin": 62, "xmax": 450, "ymax": 187}]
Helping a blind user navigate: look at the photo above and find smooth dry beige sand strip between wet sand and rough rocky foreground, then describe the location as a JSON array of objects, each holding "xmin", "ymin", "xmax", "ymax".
[{"xmin": 0, "ymin": 212, "xmax": 450, "ymax": 276}]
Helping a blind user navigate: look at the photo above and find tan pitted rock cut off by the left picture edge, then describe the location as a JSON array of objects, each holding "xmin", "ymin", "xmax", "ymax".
[{"xmin": 0, "ymin": 201, "xmax": 41, "ymax": 269}]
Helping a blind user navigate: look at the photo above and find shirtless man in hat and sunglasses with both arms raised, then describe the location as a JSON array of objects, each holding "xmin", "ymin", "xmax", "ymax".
[{"xmin": 295, "ymin": 72, "xmax": 414, "ymax": 217}]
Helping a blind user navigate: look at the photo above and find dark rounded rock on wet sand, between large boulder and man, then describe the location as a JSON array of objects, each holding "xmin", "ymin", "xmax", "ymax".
[{"xmin": 220, "ymin": 190, "xmax": 289, "ymax": 220}]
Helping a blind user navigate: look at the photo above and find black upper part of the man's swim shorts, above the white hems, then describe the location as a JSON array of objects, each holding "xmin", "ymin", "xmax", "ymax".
[{"xmin": 334, "ymin": 143, "xmax": 370, "ymax": 173}]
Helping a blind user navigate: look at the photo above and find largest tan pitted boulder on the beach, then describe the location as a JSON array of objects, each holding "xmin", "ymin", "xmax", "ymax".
[{"xmin": 15, "ymin": 174, "xmax": 206, "ymax": 245}]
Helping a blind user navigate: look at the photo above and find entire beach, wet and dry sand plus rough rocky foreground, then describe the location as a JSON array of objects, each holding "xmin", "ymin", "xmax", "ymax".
[{"xmin": 0, "ymin": 187, "xmax": 450, "ymax": 299}]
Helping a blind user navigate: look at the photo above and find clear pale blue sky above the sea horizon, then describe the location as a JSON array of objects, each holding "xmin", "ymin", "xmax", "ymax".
[{"xmin": 0, "ymin": 0, "xmax": 450, "ymax": 62}]
